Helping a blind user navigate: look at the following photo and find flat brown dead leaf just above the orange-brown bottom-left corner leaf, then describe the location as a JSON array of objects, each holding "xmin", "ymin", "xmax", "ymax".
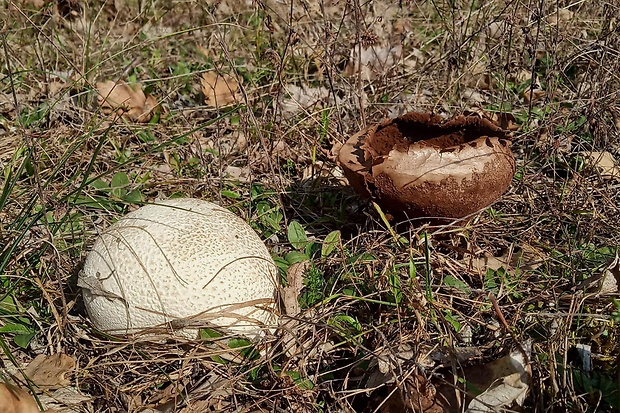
[{"xmin": 26, "ymin": 353, "xmax": 75, "ymax": 389}]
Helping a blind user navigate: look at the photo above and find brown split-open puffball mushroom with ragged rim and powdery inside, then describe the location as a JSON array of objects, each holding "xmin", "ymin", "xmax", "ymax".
[{"xmin": 338, "ymin": 112, "xmax": 515, "ymax": 218}]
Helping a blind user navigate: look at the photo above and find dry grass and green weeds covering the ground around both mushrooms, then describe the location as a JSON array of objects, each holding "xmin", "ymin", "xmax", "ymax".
[{"xmin": 0, "ymin": 0, "xmax": 620, "ymax": 413}]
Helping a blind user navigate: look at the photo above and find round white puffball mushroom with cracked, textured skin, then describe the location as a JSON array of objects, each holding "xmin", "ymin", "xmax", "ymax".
[{"xmin": 78, "ymin": 198, "xmax": 278, "ymax": 336}]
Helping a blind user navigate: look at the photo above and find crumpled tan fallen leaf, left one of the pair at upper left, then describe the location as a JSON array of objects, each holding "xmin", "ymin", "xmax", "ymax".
[{"xmin": 97, "ymin": 80, "xmax": 159, "ymax": 123}]
